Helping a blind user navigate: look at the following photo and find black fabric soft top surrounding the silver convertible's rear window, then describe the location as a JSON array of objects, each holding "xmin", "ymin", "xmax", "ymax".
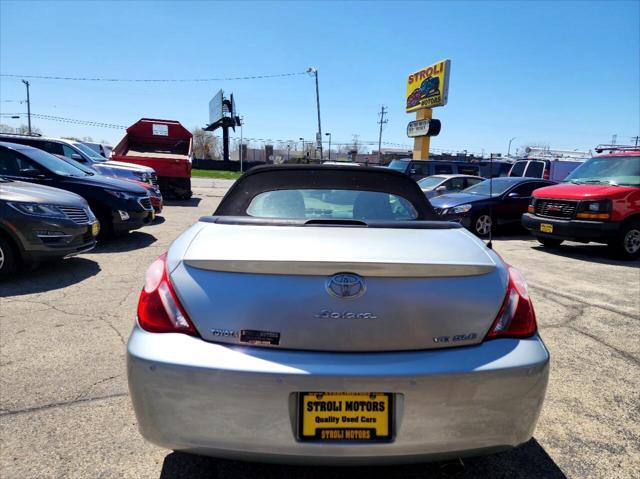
[{"xmin": 214, "ymin": 165, "xmax": 439, "ymax": 221}]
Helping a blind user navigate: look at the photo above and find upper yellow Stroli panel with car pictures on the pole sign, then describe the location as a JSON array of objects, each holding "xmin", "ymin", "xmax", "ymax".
[{"xmin": 406, "ymin": 60, "xmax": 451, "ymax": 113}]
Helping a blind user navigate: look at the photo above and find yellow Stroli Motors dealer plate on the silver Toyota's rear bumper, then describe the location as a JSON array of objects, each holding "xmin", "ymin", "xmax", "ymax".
[{"xmin": 298, "ymin": 392, "xmax": 393, "ymax": 442}]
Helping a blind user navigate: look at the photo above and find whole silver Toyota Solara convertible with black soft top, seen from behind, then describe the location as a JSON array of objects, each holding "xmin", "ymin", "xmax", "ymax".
[{"xmin": 127, "ymin": 166, "xmax": 549, "ymax": 464}]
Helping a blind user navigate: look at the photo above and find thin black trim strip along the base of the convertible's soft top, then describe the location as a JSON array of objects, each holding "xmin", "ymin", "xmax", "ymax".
[{"xmin": 199, "ymin": 215, "xmax": 463, "ymax": 230}]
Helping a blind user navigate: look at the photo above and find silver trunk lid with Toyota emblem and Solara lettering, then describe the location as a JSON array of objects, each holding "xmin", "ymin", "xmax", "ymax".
[{"xmin": 169, "ymin": 224, "xmax": 507, "ymax": 351}]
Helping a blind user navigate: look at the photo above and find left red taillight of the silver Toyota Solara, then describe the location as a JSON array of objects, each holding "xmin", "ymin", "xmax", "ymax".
[{"xmin": 138, "ymin": 253, "xmax": 198, "ymax": 336}]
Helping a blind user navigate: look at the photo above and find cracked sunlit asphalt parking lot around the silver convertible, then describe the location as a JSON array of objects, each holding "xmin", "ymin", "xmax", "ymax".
[{"xmin": 0, "ymin": 180, "xmax": 640, "ymax": 479}]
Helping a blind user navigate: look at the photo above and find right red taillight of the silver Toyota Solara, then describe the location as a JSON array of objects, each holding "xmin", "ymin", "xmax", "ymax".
[{"xmin": 485, "ymin": 266, "xmax": 538, "ymax": 339}]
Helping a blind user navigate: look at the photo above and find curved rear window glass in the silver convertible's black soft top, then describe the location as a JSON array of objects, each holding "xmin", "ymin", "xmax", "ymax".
[{"xmin": 246, "ymin": 189, "xmax": 418, "ymax": 221}]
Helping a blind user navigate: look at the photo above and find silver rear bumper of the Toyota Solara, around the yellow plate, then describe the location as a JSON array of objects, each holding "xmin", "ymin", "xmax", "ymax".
[{"xmin": 127, "ymin": 326, "xmax": 549, "ymax": 464}]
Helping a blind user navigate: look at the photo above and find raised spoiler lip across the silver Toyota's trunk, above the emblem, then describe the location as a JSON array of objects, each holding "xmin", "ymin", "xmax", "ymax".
[{"xmin": 182, "ymin": 259, "xmax": 497, "ymax": 278}]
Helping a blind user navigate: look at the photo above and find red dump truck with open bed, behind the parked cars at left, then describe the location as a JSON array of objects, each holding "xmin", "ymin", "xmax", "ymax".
[{"xmin": 111, "ymin": 118, "xmax": 193, "ymax": 199}]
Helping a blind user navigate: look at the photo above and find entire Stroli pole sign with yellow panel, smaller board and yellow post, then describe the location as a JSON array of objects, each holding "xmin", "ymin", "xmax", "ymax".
[{"xmin": 405, "ymin": 60, "xmax": 451, "ymax": 160}]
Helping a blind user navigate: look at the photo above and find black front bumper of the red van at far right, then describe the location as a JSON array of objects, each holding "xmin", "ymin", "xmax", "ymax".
[{"xmin": 522, "ymin": 213, "xmax": 620, "ymax": 243}]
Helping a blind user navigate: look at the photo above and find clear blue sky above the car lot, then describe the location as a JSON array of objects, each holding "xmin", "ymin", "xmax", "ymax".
[{"xmin": 0, "ymin": 1, "xmax": 640, "ymax": 153}]
